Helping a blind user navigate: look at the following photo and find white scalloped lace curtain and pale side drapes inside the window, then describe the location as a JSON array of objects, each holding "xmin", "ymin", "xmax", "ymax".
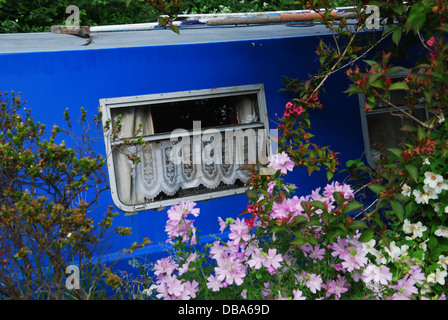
[{"xmin": 112, "ymin": 99, "xmax": 258, "ymax": 205}]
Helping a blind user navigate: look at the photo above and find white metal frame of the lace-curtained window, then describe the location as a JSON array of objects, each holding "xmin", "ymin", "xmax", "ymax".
[{"xmin": 99, "ymin": 84, "xmax": 272, "ymax": 214}]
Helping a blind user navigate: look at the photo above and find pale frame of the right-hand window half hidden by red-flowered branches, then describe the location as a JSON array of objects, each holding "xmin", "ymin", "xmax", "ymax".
[{"xmin": 358, "ymin": 70, "xmax": 428, "ymax": 168}]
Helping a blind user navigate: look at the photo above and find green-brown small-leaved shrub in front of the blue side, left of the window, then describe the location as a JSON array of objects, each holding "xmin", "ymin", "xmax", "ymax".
[{"xmin": 0, "ymin": 93, "xmax": 133, "ymax": 299}]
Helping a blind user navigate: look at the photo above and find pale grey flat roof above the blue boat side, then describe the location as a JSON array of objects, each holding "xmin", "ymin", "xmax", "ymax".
[{"xmin": 0, "ymin": 22, "xmax": 336, "ymax": 53}]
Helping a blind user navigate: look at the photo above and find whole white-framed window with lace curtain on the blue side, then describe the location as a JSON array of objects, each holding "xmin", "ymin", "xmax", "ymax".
[{"xmin": 100, "ymin": 85, "xmax": 271, "ymax": 212}]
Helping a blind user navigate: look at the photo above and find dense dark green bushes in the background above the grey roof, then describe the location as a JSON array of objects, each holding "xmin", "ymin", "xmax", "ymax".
[{"xmin": 0, "ymin": 0, "xmax": 348, "ymax": 33}]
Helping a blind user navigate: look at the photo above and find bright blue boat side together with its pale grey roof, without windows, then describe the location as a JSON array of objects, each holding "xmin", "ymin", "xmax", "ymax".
[{"xmin": 0, "ymin": 24, "xmax": 364, "ymax": 268}]
